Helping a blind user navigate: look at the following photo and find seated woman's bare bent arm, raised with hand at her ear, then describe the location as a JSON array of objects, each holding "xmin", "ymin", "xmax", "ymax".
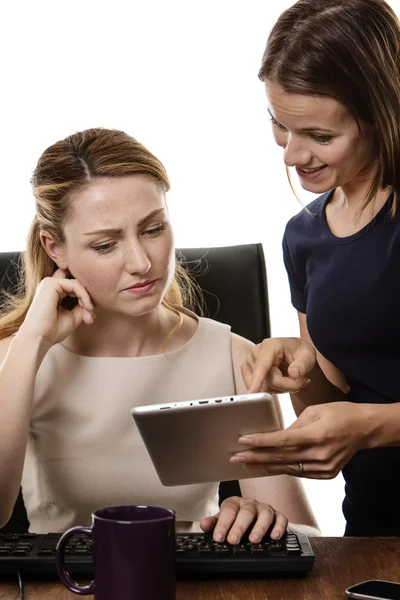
[{"xmin": 0, "ymin": 269, "xmax": 93, "ymax": 526}]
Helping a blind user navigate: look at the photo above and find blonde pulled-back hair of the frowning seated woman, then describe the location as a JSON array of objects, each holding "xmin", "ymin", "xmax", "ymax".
[{"xmin": 0, "ymin": 128, "xmax": 198, "ymax": 339}]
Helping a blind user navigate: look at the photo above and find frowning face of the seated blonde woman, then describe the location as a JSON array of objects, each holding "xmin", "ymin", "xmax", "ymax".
[{"xmin": 62, "ymin": 175, "xmax": 175, "ymax": 316}]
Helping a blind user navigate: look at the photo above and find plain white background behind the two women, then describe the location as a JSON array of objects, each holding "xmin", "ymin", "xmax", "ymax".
[{"xmin": 0, "ymin": 0, "xmax": 400, "ymax": 535}]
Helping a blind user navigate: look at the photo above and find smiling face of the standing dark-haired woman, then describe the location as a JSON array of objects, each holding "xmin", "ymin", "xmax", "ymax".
[{"xmin": 266, "ymin": 83, "xmax": 375, "ymax": 194}]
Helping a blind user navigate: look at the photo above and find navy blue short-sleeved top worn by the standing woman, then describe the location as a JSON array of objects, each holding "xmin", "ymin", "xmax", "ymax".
[{"xmin": 283, "ymin": 191, "xmax": 400, "ymax": 536}]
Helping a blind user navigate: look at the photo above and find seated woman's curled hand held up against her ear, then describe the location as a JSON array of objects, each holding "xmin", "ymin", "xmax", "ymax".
[{"xmin": 20, "ymin": 269, "xmax": 95, "ymax": 346}]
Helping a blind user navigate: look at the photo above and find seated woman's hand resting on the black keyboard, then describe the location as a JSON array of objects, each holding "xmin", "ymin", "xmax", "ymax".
[{"xmin": 200, "ymin": 496, "xmax": 288, "ymax": 544}]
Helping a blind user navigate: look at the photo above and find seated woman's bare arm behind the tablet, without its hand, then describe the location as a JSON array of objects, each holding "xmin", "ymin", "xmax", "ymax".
[{"xmin": 232, "ymin": 334, "xmax": 320, "ymax": 535}]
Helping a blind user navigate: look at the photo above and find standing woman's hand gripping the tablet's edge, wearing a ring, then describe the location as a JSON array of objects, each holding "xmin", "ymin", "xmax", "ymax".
[{"xmin": 230, "ymin": 402, "xmax": 376, "ymax": 479}]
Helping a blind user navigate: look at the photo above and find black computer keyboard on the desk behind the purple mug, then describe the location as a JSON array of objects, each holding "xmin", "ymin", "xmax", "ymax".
[{"xmin": 0, "ymin": 533, "xmax": 314, "ymax": 579}]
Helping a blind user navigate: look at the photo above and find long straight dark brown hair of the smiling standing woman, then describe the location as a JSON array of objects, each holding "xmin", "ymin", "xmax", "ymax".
[{"xmin": 258, "ymin": 0, "xmax": 400, "ymax": 215}]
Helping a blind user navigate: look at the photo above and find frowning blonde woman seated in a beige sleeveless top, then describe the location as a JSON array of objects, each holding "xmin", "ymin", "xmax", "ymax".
[{"xmin": 0, "ymin": 129, "xmax": 315, "ymax": 543}]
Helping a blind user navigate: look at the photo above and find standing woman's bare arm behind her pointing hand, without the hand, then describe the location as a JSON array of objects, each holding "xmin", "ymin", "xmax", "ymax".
[{"xmin": 290, "ymin": 313, "xmax": 349, "ymax": 416}]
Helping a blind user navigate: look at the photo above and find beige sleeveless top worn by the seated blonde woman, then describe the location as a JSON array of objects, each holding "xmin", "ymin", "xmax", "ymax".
[{"xmin": 22, "ymin": 319, "xmax": 235, "ymax": 533}]
